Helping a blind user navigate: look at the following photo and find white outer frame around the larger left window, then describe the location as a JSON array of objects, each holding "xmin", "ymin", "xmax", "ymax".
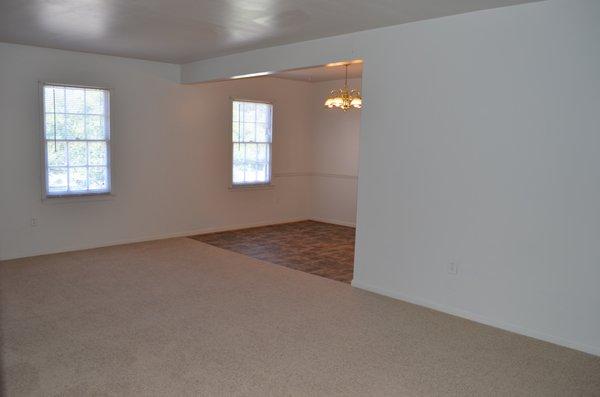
[{"xmin": 38, "ymin": 81, "xmax": 114, "ymax": 201}]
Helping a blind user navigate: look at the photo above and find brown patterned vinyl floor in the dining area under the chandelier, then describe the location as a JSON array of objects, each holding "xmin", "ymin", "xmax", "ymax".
[{"xmin": 191, "ymin": 221, "xmax": 355, "ymax": 283}]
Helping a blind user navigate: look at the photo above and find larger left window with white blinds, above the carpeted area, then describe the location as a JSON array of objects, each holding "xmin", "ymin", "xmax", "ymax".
[{"xmin": 42, "ymin": 84, "xmax": 110, "ymax": 197}]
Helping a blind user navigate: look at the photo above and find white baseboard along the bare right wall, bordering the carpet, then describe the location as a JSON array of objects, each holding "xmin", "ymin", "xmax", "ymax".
[{"xmin": 352, "ymin": 279, "xmax": 600, "ymax": 356}]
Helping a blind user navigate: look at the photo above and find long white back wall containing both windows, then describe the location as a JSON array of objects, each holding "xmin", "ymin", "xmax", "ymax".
[{"xmin": 0, "ymin": 43, "xmax": 312, "ymax": 259}]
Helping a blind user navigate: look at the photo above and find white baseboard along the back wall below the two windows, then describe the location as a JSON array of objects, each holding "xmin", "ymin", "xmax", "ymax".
[{"xmin": 0, "ymin": 217, "xmax": 307, "ymax": 261}]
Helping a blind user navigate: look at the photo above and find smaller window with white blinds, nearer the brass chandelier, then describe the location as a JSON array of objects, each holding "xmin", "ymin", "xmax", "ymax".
[{"xmin": 232, "ymin": 100, "xmax": 273, "ymax": 186}]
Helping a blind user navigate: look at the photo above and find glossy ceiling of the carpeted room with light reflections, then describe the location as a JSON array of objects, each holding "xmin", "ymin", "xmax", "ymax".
[{"xmin": 0, "ymin": 0, "xmax": 538, "ymax": 63}]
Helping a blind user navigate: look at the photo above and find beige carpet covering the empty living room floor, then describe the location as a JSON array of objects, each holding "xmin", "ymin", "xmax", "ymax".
[{"xmin": 0, "ymin": 239, "xmax": 600, "ymax": 396}]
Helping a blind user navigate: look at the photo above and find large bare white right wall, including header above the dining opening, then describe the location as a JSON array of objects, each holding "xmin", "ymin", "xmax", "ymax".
[{"xmin": 182, "ymin": 0, "xmax": 600, "ymax": 354}]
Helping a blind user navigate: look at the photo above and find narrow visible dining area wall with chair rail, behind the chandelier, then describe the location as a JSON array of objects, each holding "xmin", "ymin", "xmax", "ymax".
[{"xmin": 311, "ymin": 79, "xmax": 361, "ymax": 226}]
